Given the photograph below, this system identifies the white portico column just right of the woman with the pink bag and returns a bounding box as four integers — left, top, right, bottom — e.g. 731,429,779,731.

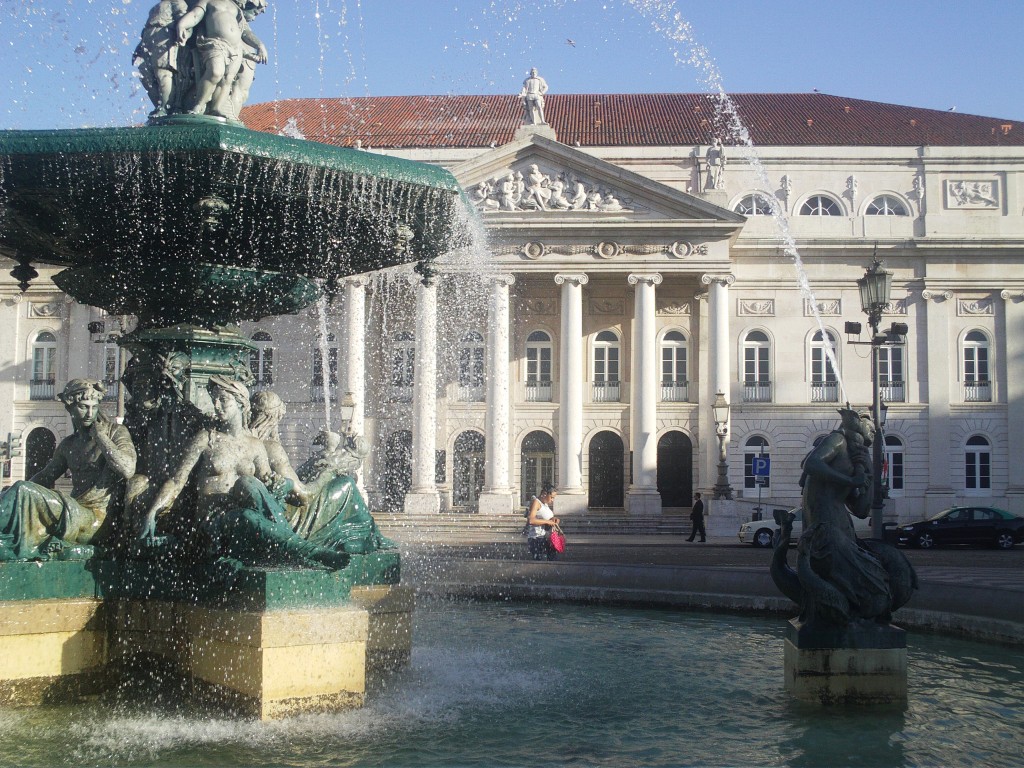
555,274,590,512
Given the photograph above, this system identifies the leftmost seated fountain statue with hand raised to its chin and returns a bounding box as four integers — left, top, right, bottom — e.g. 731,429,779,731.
0,379,135,560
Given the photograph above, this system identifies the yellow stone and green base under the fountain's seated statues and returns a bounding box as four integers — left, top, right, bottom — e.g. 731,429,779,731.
0,563,413,720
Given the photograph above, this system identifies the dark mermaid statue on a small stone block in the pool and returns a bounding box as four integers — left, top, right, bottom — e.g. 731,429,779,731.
771,409,918,627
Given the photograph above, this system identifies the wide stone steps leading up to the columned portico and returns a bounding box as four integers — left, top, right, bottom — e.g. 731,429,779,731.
374,509,690,543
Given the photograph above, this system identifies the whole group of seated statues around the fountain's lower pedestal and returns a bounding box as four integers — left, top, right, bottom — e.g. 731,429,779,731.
0,375,394,569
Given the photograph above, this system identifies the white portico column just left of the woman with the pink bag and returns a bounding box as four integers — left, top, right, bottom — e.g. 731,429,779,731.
478,274,515,514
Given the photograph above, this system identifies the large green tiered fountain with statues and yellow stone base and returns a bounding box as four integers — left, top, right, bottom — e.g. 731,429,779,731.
0,0,461,718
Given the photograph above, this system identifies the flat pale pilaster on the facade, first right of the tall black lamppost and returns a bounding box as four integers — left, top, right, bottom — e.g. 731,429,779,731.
921,289,964,515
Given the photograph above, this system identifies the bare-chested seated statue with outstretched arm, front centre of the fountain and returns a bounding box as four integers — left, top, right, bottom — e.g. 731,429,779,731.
139,375,349,569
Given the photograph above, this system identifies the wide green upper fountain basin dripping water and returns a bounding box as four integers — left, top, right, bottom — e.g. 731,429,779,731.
0,117,462,326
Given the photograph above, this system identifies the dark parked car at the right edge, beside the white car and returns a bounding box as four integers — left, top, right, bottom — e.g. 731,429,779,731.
896,507,1024,549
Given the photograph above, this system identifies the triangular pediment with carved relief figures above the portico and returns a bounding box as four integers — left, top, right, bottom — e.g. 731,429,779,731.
451,134,745,227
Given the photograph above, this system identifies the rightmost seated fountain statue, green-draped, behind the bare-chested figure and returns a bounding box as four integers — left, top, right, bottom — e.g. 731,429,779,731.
252,391,395,554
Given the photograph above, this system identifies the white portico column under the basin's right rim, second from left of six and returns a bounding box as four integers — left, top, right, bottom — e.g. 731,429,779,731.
406,281,440,514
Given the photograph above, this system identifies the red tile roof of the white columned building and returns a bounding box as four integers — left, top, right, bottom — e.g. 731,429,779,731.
242,93,1024,148
